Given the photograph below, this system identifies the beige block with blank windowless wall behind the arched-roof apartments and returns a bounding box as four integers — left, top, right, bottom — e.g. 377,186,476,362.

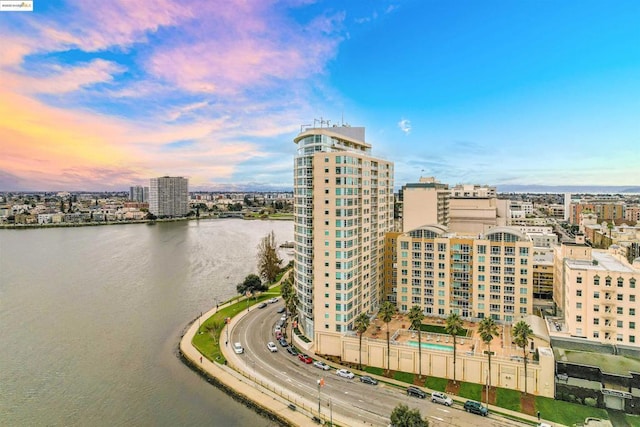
400,177,449,230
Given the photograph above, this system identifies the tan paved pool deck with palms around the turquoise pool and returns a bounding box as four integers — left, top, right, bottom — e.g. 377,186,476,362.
363,314,548,358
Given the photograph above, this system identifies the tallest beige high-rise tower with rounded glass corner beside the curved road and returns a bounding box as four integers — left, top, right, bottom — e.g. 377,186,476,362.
294,125,394,348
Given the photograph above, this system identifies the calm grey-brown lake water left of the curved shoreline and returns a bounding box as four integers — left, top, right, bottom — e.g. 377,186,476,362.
0,219,293,427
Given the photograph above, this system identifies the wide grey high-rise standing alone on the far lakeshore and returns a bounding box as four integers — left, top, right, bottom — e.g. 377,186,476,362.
149,176,189,218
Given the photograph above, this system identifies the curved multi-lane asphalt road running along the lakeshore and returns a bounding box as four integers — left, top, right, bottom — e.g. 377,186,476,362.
230,300,528,427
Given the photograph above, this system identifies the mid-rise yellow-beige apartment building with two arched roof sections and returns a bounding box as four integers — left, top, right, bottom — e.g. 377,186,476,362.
394,225,533,323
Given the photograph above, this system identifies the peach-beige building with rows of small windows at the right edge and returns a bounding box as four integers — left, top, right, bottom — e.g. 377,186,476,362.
554,238,640,347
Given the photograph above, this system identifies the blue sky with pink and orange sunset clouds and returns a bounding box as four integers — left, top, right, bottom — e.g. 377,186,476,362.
0,0,640,191
